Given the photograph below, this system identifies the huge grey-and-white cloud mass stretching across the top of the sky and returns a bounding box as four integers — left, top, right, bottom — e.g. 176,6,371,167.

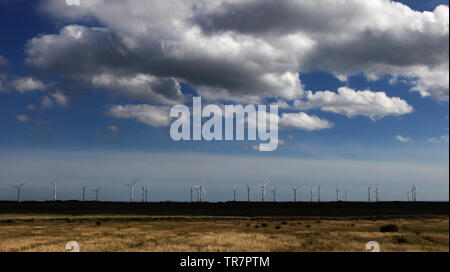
27,0,449,103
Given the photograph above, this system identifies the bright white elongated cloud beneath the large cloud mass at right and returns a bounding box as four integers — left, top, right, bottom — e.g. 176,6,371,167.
294,87,413,120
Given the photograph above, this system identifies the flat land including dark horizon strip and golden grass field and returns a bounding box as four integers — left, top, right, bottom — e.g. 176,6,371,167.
0,202,449,252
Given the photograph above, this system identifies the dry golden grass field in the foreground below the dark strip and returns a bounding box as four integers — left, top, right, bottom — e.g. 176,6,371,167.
0,214,449,252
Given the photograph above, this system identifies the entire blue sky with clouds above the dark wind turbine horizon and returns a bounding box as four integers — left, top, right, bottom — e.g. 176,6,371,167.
0,0,449,201
